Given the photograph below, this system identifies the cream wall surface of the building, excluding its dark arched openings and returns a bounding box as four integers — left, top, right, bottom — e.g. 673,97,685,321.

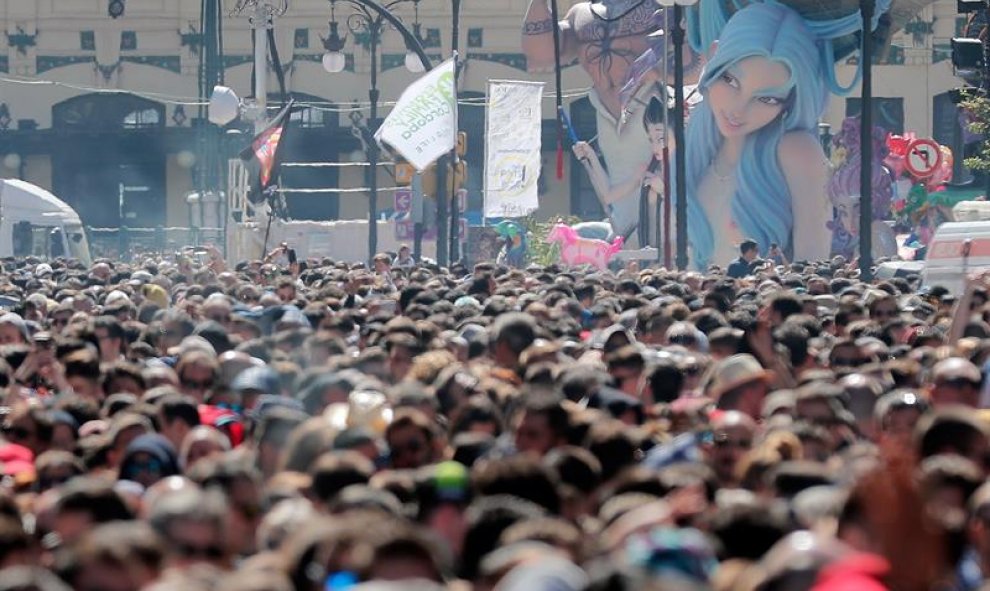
0,0,976,231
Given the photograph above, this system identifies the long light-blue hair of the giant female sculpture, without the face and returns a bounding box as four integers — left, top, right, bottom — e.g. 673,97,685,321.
685,0,890,268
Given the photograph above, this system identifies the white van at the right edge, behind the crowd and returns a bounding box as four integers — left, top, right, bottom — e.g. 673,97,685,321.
921,221,990,295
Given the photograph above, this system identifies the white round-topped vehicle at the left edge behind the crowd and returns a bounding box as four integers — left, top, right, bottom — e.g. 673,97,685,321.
0,179,91,265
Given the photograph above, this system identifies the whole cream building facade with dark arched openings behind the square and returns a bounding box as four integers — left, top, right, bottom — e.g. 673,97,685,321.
0,0,980,236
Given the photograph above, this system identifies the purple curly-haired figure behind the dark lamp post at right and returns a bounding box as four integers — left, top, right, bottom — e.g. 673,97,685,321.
828,117,897,259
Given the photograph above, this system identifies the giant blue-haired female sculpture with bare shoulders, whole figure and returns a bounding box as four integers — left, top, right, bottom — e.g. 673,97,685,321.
685,0,889,268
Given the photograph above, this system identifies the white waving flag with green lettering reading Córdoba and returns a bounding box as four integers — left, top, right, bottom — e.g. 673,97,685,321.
375,59,457,171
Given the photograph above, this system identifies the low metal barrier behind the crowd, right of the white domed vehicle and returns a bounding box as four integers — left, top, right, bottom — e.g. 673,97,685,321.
86,226,224,262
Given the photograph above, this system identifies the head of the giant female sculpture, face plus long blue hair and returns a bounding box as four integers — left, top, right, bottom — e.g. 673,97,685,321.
686,3,828,268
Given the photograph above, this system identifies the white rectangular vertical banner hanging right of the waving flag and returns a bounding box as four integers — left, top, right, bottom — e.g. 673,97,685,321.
485,80,543,218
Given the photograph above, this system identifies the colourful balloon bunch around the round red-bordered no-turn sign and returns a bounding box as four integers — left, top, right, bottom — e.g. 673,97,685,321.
885,132,960,250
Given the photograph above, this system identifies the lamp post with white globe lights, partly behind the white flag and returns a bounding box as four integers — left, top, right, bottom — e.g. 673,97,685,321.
323,0,431,260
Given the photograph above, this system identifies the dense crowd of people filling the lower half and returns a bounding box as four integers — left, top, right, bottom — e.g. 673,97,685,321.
0,249,990,591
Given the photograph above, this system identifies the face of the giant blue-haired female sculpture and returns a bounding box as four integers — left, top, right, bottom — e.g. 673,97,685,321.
708,56,791,138
